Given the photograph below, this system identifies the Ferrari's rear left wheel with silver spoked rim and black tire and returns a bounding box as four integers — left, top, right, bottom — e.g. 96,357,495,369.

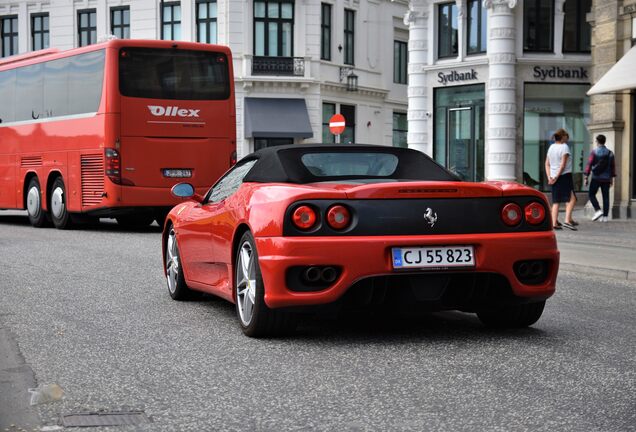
234,231,298,338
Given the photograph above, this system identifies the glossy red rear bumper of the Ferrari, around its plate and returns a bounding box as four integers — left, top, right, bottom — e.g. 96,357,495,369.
256,231,559,308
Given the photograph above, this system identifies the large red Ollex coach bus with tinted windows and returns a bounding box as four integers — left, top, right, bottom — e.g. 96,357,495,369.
0,40,236,228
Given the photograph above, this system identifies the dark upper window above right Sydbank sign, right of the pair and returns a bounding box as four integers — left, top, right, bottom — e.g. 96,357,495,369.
563,0,592,53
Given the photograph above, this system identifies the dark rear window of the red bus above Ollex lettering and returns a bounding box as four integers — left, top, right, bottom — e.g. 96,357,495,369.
119,48,230,100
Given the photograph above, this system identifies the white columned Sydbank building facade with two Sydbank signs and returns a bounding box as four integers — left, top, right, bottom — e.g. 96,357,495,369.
405,0,592,192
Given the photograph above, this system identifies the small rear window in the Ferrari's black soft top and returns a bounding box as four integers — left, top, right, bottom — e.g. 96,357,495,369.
300,152,398,177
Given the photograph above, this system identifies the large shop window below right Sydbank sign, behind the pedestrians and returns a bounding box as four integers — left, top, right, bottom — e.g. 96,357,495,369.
523,83,592,192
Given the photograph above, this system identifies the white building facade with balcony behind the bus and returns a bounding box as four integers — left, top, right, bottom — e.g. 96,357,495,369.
0,0,408,157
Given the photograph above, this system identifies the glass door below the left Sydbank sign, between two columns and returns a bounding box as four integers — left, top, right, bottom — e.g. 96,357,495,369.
446,107,477,181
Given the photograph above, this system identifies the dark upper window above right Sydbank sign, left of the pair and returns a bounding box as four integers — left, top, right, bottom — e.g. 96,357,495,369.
523,0,554,52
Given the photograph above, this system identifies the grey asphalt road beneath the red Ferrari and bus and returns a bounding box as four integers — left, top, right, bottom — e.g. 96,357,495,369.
0,212,636,431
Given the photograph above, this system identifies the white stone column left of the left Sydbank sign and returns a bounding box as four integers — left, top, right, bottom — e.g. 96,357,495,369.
404,0,433,156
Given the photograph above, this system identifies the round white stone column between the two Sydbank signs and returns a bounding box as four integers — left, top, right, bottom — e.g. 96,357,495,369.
484,0,517,180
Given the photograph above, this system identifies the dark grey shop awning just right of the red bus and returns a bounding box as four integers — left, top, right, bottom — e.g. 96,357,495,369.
244,98,314,138
